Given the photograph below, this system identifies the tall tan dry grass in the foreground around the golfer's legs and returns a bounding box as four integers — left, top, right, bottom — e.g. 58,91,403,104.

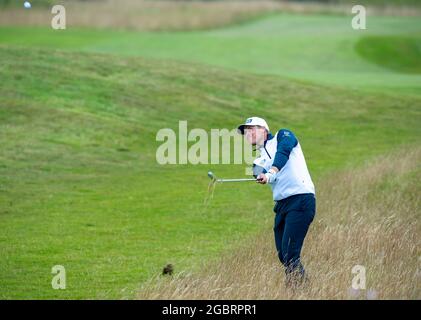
138,148,421,299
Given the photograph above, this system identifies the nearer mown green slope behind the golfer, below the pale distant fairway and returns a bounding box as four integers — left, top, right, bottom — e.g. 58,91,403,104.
0,47,421,298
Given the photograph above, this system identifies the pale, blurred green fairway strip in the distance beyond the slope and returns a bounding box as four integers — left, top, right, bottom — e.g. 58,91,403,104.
0,14,421,95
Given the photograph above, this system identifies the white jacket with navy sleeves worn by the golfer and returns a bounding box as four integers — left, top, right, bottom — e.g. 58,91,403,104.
253,129,315,201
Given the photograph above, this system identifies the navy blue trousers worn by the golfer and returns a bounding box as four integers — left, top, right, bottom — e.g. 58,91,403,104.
273,193,316,283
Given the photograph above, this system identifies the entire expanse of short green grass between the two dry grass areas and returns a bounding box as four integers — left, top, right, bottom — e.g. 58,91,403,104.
0,11,421,299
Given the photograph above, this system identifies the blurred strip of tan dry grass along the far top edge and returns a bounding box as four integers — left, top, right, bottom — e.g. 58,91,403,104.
0,0,421,31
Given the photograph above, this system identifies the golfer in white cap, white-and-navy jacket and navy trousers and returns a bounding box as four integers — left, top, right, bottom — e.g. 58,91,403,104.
238,117,316,287
